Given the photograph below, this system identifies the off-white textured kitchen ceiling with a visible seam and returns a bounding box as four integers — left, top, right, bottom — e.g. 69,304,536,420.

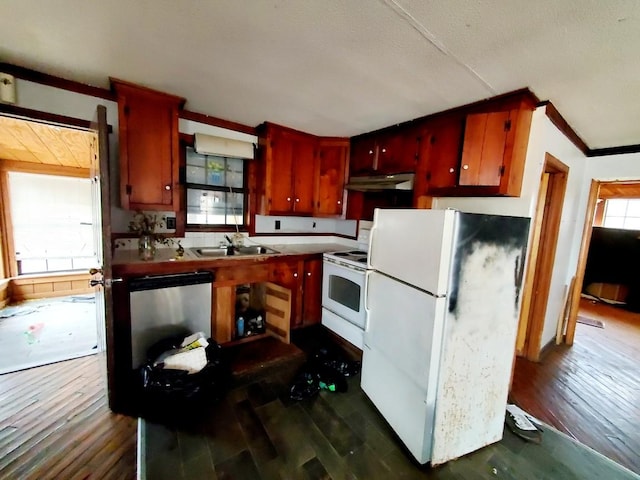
0,0,640,149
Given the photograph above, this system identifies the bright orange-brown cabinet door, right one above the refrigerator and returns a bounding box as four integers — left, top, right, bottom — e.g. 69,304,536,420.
459,111,511,187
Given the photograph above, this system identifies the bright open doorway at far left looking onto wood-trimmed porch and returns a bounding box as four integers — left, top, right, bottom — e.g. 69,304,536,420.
0,116,99,373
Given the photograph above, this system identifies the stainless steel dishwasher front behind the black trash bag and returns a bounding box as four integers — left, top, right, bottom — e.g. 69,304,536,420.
129,272,213,368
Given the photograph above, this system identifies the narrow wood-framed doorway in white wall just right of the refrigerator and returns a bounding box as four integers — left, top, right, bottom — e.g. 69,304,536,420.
516,153,569,361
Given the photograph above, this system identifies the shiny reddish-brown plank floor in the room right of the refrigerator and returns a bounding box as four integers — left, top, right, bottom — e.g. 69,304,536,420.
511,298,640,474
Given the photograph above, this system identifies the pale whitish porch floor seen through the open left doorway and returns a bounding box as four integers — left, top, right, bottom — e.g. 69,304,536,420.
0,295,98,374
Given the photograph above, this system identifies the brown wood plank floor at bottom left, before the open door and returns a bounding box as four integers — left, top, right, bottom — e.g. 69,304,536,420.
0,355,137,480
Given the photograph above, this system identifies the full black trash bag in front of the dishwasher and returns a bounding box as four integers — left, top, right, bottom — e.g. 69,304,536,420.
139,337,231,420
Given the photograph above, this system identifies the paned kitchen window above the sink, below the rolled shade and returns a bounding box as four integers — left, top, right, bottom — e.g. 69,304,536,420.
186,147,246,229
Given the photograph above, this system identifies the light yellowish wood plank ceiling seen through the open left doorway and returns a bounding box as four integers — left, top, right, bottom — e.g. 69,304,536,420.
0,116,94,169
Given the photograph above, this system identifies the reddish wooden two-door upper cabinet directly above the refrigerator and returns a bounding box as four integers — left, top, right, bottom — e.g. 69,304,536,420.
414,93,535,198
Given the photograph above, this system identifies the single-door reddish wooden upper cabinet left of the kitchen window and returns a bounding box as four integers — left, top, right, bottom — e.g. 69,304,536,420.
111,79,185,211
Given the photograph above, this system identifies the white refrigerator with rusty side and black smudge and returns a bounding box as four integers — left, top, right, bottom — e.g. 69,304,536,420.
361,209,529,465
